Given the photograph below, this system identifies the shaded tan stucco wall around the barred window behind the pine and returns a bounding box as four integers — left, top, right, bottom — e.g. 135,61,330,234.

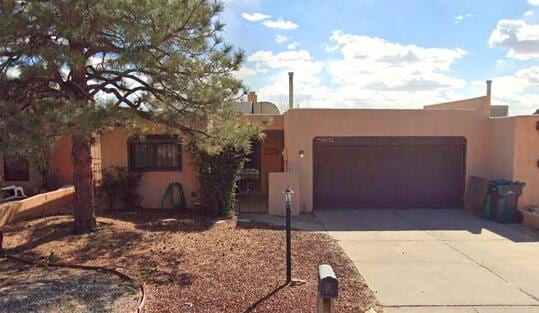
101,129,197,208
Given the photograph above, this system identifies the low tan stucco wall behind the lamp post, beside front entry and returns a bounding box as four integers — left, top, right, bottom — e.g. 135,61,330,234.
268,172,301,216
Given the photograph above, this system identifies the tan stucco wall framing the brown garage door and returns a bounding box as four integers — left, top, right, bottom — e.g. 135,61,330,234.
284,103,496,211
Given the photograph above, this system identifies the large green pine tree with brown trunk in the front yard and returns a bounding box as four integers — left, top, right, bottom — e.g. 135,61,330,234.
0,0,243,233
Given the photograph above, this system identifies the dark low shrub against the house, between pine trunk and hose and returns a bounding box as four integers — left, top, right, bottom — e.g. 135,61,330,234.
102,166,143,211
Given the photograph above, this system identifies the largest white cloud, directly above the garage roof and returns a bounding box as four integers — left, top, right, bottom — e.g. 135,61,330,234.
316,31,466,108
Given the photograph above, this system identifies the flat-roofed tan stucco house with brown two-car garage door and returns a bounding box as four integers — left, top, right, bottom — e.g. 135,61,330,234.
0,83,539,214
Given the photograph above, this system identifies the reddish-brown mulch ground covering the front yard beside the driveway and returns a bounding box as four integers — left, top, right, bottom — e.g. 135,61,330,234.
4,212,381,313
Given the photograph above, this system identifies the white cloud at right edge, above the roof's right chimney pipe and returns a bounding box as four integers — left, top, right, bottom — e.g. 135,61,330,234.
489,17,539,60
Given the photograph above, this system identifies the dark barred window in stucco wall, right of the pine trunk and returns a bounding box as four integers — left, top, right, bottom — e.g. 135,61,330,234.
129,135,182,171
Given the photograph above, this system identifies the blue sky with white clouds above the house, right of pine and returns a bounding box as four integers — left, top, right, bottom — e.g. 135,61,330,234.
220,0,539,115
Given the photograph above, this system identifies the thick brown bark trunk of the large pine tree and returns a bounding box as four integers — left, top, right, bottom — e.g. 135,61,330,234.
71,135,96,234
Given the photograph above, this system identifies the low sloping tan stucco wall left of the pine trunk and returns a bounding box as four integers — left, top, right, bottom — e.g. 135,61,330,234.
0,187,75,227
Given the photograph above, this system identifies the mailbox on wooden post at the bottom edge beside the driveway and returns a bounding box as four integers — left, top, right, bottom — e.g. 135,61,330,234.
318,264,339,313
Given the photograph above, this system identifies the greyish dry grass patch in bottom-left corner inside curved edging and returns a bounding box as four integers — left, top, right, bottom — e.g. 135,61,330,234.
0,258,139,313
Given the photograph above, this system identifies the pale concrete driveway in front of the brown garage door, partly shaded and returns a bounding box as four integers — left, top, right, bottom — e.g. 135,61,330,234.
316,209,539,313
